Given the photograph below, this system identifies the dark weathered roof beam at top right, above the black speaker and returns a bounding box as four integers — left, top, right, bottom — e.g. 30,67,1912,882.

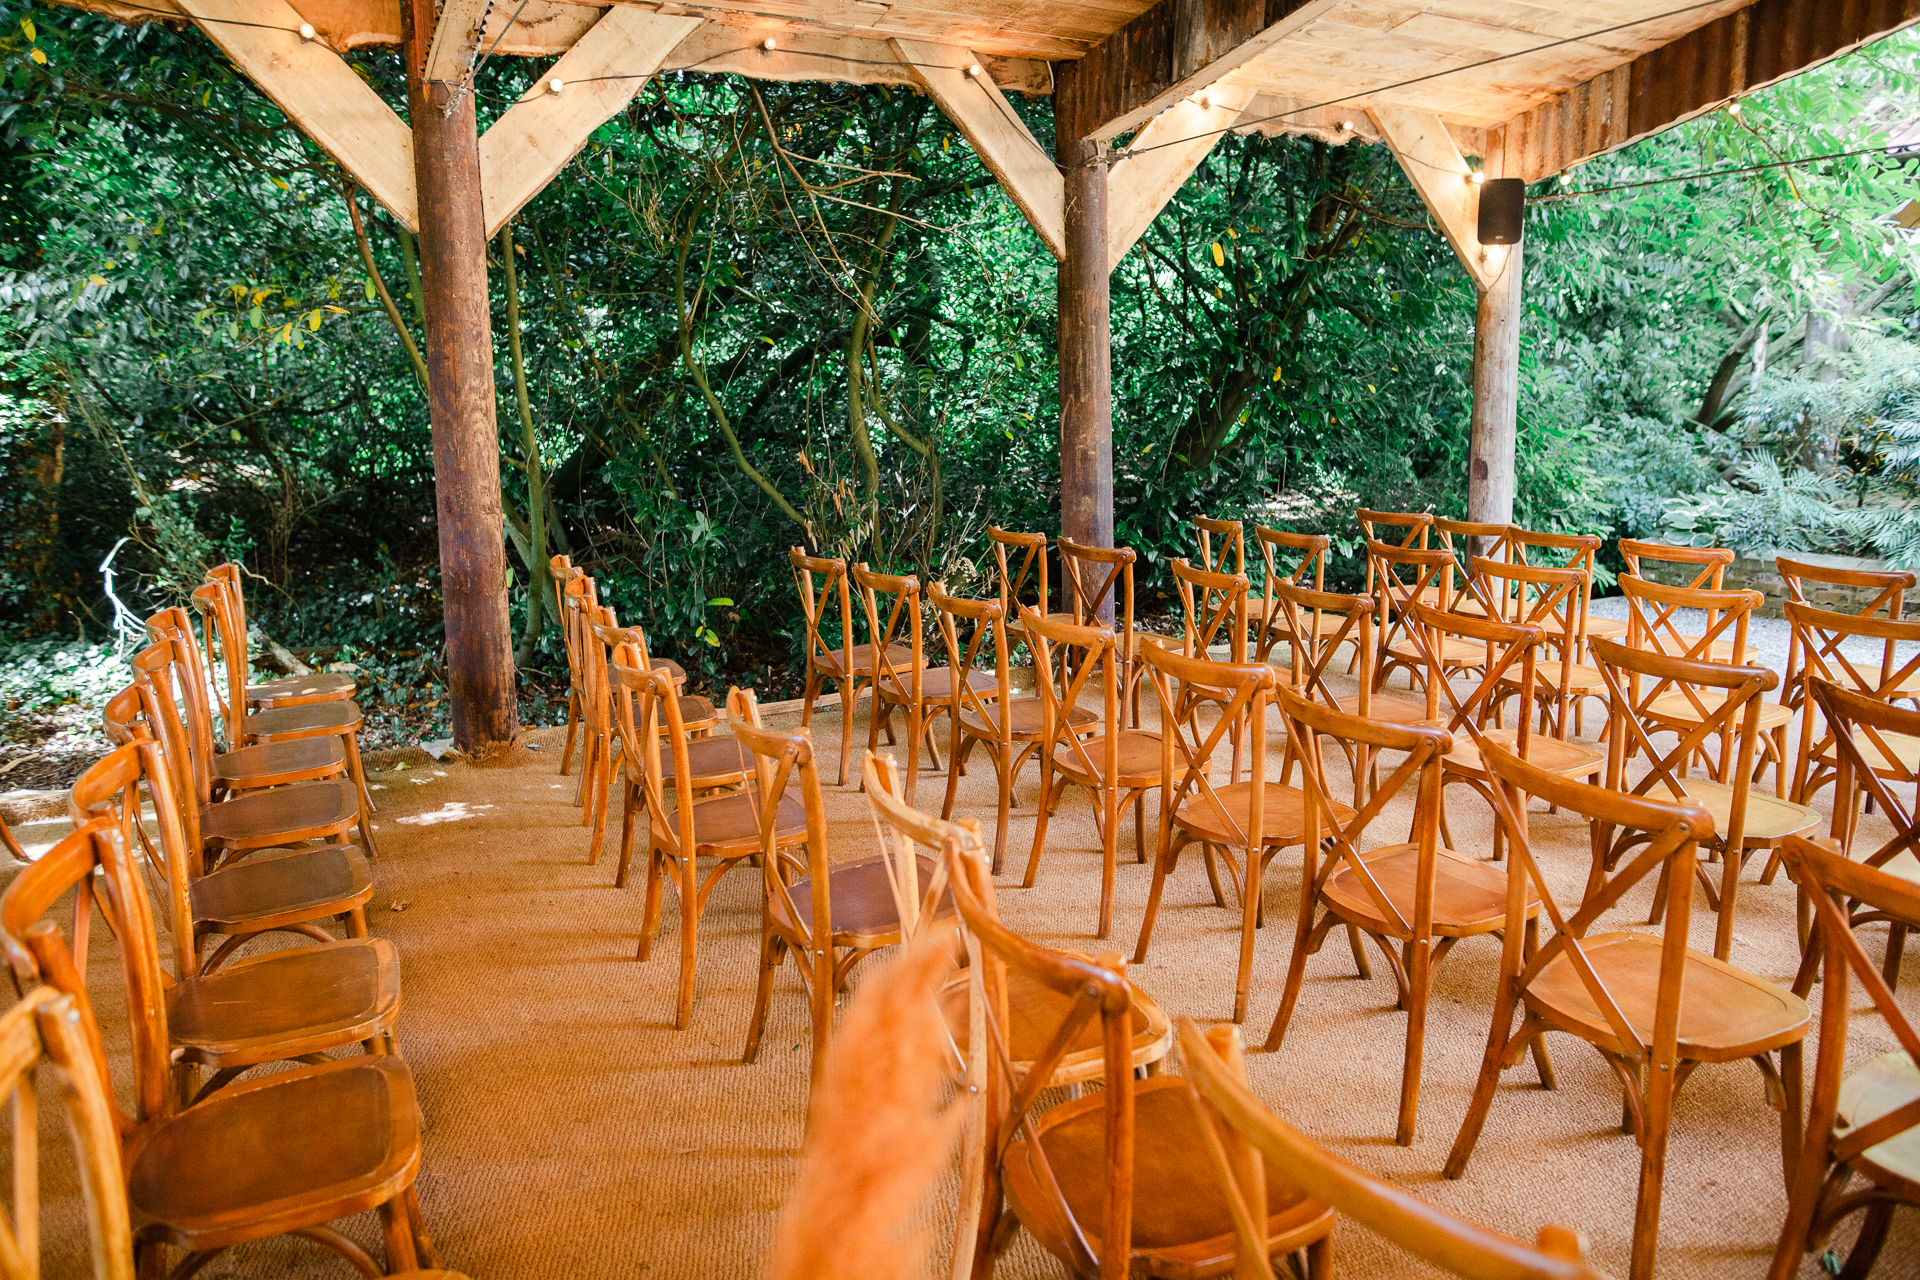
1501,0,1920,182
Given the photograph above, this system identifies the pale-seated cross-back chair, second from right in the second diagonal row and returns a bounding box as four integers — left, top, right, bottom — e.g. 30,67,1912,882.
1590,639,1820,960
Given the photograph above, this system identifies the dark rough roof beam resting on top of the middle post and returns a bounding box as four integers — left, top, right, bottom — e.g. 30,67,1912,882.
1054,0,1342,142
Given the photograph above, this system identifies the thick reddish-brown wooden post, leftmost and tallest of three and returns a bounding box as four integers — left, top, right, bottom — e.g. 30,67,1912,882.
399,0,518,756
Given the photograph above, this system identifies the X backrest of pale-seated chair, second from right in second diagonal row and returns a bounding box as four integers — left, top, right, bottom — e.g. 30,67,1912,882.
1594,635,1780,835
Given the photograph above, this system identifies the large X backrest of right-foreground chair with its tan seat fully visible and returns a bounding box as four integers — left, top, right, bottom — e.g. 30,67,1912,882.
1480,741,1713,1071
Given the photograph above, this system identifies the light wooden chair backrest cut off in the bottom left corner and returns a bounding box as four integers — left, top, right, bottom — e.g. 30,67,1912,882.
0,986,134,1280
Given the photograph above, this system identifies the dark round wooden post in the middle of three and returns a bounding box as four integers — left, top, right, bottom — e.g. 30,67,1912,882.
1054,63,1114,560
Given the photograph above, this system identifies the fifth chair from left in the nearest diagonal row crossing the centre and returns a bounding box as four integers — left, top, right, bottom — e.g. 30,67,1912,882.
1133,645,1328,1021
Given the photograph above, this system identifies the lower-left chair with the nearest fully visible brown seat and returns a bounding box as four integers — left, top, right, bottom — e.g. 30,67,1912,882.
0,825,440,1276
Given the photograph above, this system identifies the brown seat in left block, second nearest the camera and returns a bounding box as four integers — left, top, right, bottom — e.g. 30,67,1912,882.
167,938,399,1067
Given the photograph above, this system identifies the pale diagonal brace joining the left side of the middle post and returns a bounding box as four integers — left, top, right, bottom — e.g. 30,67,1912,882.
887,40,1066,257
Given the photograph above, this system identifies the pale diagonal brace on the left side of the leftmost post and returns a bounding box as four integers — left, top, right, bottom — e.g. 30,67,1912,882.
179,0,420,230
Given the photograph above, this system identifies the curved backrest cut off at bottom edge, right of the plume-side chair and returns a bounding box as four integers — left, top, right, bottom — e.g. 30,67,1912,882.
1179,1017,1603,1280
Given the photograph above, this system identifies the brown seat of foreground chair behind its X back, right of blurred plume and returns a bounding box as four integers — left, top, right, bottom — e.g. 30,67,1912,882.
1002,1077,1332,1276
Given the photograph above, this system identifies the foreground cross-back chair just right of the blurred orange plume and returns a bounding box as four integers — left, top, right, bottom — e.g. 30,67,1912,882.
947,825,1332,1280
